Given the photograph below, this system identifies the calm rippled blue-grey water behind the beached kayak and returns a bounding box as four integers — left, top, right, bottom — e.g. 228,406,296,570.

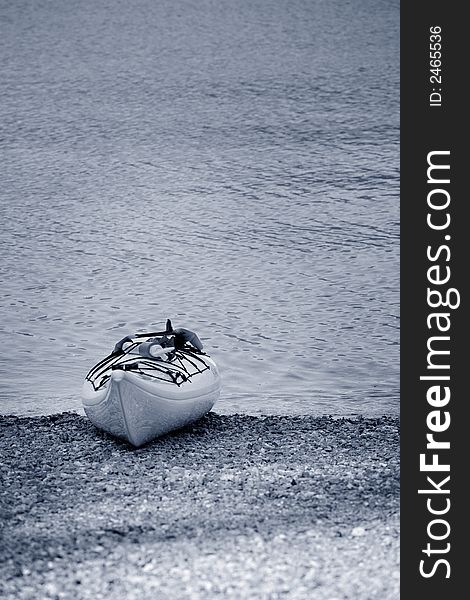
0,0,399,415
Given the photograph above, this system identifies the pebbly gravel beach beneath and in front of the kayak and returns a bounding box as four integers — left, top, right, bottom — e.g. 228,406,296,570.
0,413,399,600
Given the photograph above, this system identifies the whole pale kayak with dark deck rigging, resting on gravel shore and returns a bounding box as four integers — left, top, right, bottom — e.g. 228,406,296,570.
82,321,221,446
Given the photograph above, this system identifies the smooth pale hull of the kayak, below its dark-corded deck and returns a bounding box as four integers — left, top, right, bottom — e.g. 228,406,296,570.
82,358,220,447
